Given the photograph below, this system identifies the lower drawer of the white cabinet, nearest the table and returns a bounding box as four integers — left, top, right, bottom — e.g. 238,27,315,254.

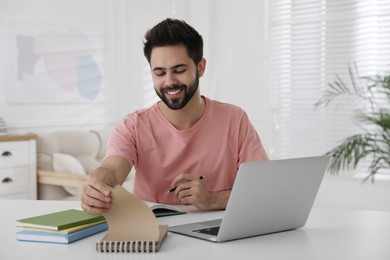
0,167,30,195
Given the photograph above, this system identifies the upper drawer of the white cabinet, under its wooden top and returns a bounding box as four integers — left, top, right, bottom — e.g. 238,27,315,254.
0,141,30,167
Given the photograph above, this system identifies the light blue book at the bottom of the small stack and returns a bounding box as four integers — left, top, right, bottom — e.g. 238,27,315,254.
16,222,108,244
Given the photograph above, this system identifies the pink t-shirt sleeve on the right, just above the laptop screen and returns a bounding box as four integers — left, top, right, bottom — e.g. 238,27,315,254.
238,112,269,165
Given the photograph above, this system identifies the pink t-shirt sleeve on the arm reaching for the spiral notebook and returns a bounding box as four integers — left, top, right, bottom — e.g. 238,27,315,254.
104,115,137,168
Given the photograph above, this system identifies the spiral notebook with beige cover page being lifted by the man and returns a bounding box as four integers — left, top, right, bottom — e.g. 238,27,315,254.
96,186,168,252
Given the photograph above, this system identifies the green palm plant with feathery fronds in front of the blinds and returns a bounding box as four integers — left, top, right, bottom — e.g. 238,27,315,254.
315,64,390,181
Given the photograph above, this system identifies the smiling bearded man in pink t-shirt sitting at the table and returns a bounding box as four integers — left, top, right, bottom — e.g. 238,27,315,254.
81,19,268,214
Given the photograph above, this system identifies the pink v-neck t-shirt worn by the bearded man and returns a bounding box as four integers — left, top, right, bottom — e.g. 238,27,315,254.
106,98,268,204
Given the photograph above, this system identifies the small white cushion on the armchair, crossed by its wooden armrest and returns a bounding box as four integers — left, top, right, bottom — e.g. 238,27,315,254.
53,153,87,195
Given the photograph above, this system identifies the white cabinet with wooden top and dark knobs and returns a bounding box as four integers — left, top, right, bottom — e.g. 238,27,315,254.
0,135,37,199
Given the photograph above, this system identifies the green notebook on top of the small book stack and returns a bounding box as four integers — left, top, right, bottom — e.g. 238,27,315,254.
16,209,105,230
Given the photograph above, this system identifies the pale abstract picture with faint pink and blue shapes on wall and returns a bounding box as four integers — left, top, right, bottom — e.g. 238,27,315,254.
6,21,105,104
